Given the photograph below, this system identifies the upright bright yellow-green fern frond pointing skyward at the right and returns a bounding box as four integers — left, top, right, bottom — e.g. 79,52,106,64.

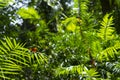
98,14,115,41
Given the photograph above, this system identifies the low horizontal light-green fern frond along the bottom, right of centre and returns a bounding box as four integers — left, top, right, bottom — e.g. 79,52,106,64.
55,65,98,78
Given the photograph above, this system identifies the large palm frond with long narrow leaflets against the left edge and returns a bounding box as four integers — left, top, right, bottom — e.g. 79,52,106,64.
0,37,29,78
